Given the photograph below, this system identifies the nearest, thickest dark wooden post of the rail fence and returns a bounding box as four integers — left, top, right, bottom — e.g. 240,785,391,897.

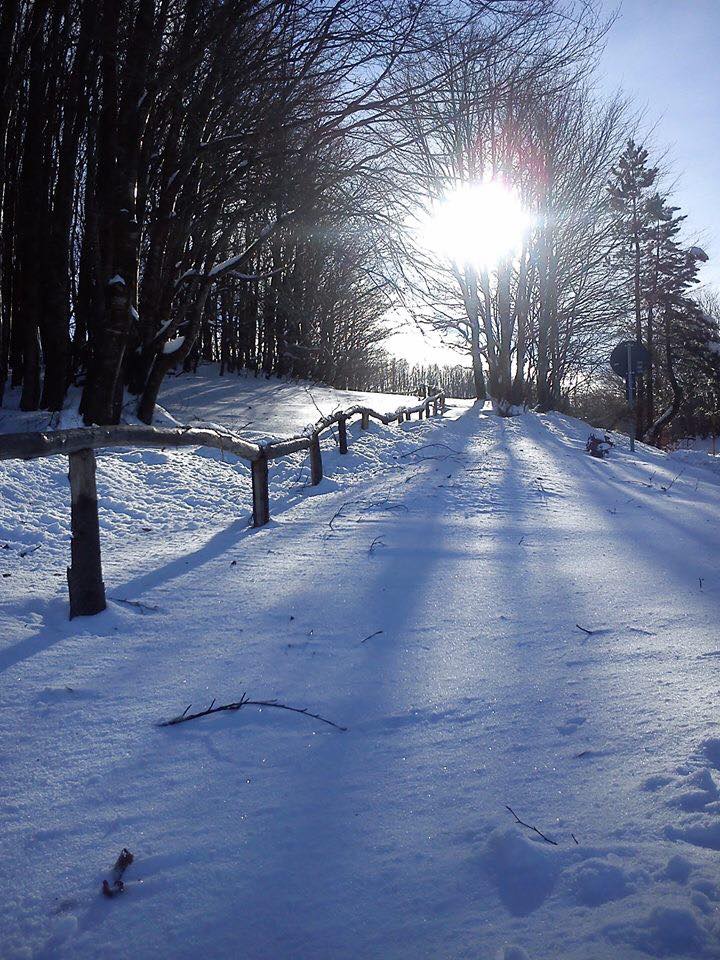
67,450,107,620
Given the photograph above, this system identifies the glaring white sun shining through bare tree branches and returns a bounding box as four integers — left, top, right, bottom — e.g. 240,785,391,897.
424,180,531,269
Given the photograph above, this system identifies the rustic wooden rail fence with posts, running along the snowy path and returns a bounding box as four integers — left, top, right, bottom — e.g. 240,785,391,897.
0,391,445,618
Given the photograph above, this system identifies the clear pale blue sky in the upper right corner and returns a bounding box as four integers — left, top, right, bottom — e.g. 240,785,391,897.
600,0,720,288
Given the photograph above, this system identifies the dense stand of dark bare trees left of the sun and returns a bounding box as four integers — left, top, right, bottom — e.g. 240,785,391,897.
0,0,450,423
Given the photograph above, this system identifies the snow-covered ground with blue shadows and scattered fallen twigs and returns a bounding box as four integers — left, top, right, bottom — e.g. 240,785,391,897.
0,378,720,960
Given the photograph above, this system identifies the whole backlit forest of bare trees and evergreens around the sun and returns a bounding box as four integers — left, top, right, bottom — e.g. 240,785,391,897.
0,0,720,445
